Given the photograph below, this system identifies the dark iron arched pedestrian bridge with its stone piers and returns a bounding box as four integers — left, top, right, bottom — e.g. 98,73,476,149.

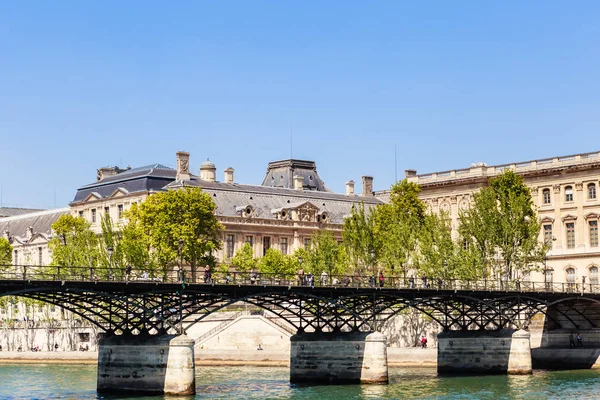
0,266,600,393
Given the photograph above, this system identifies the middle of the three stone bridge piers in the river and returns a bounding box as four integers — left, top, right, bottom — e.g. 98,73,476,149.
290,332,388,384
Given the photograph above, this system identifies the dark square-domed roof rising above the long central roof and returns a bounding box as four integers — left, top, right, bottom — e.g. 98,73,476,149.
262,159,329,192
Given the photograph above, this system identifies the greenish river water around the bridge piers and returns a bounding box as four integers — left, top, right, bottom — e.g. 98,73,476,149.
0,364,600,400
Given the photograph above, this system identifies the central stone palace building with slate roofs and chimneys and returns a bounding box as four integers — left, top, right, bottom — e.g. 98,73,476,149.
70,152,381,262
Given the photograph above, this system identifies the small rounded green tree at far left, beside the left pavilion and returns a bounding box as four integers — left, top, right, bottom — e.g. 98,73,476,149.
48,214,99,277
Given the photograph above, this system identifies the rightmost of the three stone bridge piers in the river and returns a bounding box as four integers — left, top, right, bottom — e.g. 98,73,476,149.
438,329,532,375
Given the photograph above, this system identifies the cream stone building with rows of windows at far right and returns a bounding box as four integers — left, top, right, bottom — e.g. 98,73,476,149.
375,152,600,284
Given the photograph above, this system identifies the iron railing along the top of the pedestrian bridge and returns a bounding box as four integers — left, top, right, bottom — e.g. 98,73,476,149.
0,265,600,294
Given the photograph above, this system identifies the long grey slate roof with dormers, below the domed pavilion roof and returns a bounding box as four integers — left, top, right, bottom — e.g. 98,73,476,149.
168,177,383,224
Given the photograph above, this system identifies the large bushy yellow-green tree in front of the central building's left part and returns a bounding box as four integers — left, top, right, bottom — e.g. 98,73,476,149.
124,187,223,280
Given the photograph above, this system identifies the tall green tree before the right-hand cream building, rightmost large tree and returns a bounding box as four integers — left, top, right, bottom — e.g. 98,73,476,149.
459,171,545,279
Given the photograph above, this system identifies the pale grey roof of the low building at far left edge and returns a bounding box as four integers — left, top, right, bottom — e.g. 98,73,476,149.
0,208,69,242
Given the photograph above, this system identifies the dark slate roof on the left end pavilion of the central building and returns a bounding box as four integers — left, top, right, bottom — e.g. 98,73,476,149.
71,164,177,204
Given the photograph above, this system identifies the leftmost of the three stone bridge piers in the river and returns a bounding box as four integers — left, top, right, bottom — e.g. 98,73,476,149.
98,335,196,395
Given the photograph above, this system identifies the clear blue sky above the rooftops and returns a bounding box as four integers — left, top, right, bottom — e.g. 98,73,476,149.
0,0,600,207
